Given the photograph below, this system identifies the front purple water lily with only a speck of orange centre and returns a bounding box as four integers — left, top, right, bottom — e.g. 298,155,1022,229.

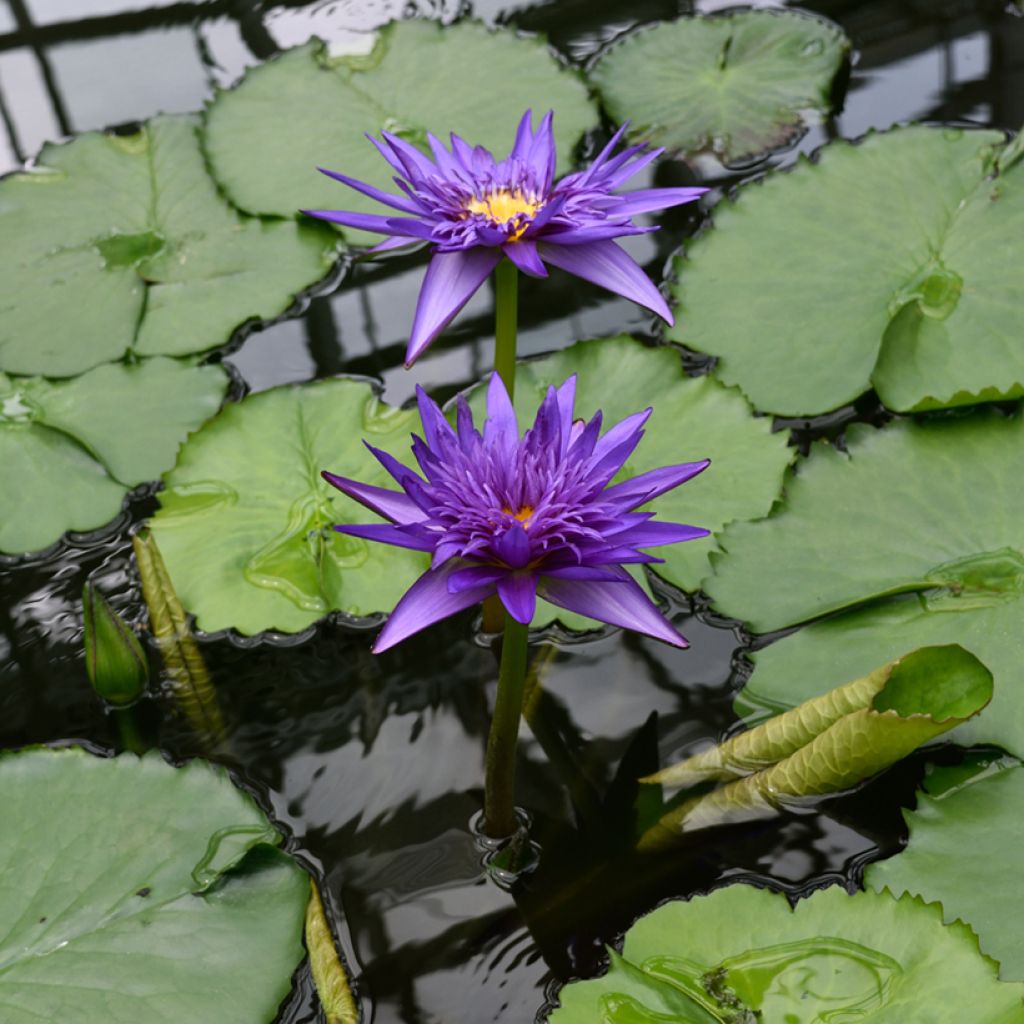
323,374,709,652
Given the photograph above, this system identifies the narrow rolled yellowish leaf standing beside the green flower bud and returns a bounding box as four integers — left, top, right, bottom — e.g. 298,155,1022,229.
131,529,224,745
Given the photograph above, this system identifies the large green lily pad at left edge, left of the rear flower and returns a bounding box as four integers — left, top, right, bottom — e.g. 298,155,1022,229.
0,117,336,377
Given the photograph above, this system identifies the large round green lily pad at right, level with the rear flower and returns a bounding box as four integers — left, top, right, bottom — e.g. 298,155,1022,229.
669,126,1024,416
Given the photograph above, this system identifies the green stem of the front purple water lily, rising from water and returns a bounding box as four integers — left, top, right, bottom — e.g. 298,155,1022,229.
483,614,529,839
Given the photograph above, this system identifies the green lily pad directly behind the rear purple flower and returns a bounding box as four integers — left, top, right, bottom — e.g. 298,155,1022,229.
206,20,598,245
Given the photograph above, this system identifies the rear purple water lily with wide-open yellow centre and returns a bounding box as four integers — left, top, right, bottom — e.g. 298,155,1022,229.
303,111,708,366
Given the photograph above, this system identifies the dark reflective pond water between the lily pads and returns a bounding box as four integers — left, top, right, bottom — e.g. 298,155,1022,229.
0,0,1024,1024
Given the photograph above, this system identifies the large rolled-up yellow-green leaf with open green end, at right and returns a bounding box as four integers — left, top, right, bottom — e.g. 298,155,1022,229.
640,644,992,849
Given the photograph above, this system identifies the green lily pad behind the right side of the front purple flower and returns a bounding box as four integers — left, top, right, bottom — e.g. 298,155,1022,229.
462,336,796,629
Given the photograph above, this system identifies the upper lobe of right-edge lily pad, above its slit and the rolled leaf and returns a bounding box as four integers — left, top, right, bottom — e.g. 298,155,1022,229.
706,412,1024,634
